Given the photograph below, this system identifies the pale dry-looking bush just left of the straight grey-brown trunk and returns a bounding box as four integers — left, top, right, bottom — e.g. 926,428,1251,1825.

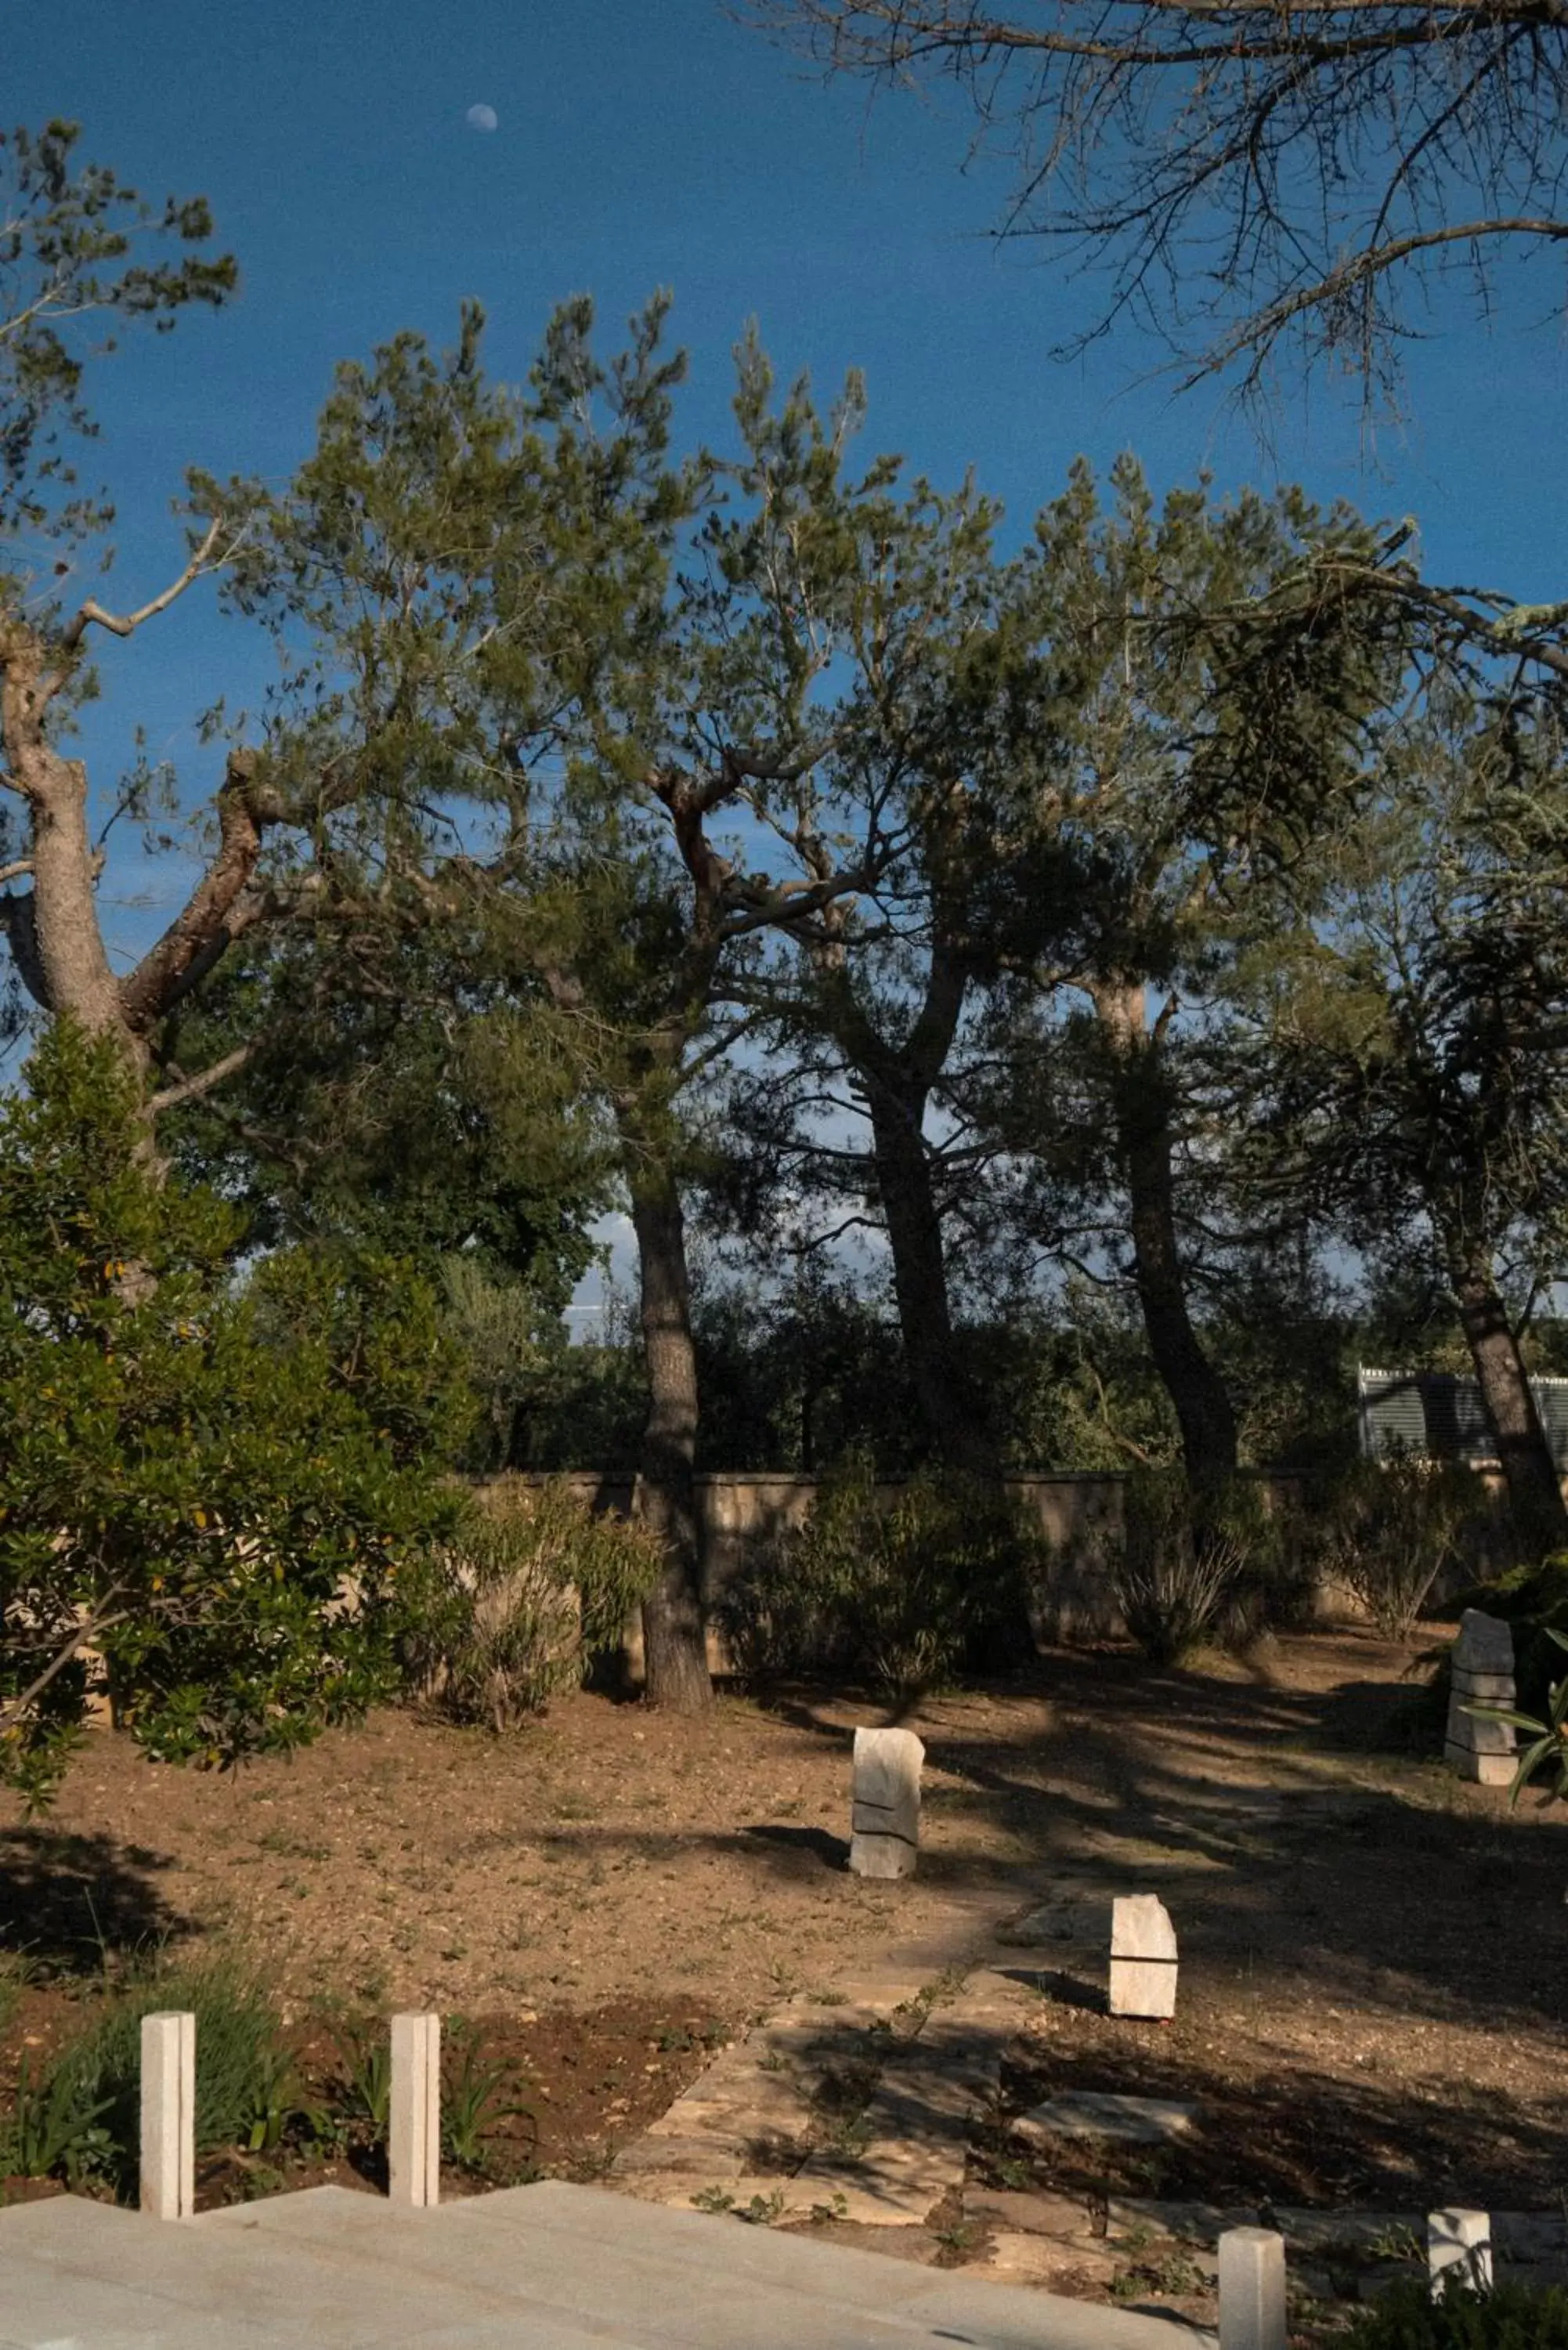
399,1478,663,1730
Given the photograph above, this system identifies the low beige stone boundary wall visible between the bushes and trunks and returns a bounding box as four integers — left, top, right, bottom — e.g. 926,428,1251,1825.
496,1469,1316,1676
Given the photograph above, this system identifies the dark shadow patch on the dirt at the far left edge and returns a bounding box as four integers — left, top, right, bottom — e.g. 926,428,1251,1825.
0,1828,195,1974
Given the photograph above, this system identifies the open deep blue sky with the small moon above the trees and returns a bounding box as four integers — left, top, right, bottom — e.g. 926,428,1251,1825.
12,0,1568,1307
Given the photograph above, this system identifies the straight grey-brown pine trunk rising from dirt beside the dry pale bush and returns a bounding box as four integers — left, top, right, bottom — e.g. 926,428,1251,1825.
627,1137,712,1713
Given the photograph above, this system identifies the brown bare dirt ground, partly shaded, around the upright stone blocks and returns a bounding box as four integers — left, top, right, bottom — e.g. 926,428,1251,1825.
0,1633,1568,2209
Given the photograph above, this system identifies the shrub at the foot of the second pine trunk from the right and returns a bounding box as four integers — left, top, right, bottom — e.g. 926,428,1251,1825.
1110,1469,1279,1666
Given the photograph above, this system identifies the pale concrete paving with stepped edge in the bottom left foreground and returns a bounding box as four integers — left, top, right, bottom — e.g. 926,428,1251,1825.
0,2181,1201,2350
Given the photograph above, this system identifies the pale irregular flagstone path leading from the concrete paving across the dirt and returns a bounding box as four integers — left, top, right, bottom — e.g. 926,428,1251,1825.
604,1866,1568,2317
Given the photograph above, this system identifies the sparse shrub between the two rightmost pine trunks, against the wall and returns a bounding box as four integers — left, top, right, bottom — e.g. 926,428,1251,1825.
1314,1452,1488,1638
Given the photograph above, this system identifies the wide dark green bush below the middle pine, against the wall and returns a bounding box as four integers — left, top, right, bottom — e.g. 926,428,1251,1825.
714,1455,1044,1701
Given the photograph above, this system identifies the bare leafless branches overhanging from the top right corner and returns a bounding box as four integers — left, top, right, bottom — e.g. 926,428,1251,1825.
731,0,1568,392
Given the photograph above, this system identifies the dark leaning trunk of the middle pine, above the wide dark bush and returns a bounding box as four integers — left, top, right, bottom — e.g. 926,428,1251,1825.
863,1062,999,1478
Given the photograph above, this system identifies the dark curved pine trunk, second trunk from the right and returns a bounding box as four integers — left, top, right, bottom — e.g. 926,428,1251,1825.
1093,980,1237,1495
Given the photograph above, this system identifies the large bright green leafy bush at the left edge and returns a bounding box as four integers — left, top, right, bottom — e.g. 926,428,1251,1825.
0,1022,472,1802
